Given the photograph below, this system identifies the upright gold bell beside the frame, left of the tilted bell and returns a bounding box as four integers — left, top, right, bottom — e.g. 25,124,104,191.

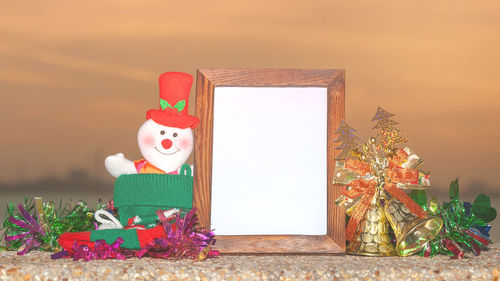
347,204,395,256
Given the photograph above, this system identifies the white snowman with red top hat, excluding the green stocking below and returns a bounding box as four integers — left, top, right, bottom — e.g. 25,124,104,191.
104,72,199,177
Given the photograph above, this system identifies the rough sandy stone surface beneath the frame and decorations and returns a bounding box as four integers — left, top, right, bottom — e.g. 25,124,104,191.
0,247,500,280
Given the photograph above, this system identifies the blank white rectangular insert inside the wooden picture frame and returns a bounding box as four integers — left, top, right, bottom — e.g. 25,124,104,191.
211,87,328,235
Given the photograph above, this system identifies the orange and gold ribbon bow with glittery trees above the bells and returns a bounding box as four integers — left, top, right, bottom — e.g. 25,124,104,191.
333,107,430,242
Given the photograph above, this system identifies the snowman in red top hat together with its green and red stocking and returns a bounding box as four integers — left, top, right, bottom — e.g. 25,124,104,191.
58,72,199,251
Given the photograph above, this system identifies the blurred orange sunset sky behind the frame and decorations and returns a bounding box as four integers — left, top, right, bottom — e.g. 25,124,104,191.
0,0,500,196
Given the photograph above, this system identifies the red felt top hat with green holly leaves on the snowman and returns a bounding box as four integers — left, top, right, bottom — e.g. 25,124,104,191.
146,72,200,129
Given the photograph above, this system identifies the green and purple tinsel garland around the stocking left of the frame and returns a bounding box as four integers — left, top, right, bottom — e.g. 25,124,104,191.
0,198,219,261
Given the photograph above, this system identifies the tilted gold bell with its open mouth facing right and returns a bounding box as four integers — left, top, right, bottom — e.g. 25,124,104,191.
384,198,443,256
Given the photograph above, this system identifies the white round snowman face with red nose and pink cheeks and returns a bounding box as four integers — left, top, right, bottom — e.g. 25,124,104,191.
137,119,193,173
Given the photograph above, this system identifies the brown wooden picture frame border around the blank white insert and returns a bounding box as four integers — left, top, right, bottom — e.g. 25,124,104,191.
193,69,346,254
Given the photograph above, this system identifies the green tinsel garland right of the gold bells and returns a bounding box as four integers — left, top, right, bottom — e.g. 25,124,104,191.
411,179,497,258
